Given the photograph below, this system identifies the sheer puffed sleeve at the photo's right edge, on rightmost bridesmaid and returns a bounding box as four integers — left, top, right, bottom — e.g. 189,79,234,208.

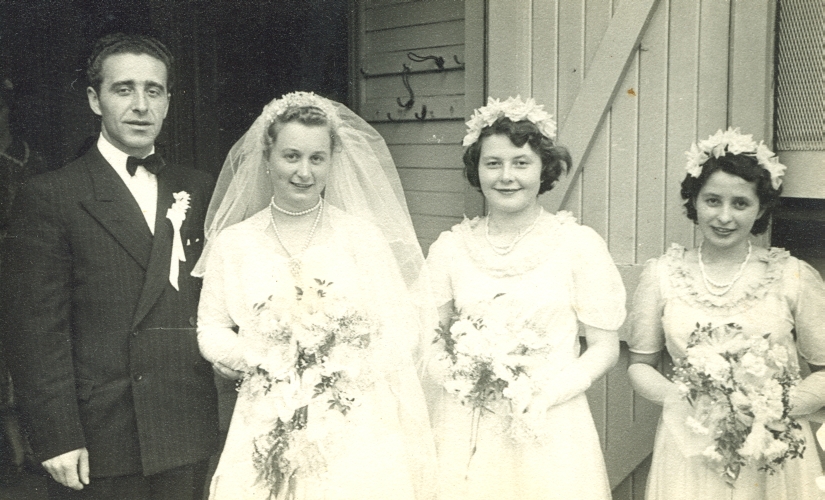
786,259,825,366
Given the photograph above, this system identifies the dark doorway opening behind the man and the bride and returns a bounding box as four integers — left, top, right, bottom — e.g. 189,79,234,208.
0,0,349,175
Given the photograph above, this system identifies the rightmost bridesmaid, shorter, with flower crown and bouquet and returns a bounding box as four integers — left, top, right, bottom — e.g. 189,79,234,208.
628,129,825,500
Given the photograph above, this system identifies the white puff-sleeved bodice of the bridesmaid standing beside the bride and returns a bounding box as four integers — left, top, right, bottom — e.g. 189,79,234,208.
427,212,625,359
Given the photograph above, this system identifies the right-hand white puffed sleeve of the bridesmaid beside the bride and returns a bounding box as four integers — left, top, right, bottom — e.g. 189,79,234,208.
572,226,626,330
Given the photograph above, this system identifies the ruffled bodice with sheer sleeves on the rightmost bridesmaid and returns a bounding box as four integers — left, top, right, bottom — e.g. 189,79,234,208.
629,244,825,364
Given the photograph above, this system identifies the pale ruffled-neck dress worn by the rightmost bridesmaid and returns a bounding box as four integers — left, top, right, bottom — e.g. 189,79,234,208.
628,244,825,500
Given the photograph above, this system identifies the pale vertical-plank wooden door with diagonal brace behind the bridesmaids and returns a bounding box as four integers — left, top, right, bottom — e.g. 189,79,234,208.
486,0,774,498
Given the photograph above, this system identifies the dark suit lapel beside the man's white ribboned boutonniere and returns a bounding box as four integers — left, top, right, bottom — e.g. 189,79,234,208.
132,170,179,328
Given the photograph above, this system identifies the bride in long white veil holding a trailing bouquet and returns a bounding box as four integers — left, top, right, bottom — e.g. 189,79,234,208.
195,92,435,500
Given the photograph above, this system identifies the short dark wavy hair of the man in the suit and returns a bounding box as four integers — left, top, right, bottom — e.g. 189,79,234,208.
86,33,174,92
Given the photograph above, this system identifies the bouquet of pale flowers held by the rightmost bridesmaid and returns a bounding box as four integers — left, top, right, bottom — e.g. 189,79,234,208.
673,323,805,486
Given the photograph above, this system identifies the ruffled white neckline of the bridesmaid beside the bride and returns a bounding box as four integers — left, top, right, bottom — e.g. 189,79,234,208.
452,210,578,278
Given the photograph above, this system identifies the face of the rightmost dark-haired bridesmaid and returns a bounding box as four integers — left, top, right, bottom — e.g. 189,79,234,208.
695,170,764,248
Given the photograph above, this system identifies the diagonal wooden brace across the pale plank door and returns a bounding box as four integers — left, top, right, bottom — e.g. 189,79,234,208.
540,0,659,212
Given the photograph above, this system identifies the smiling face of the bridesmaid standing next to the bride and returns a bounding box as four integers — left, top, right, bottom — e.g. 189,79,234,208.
478,134,541,213
